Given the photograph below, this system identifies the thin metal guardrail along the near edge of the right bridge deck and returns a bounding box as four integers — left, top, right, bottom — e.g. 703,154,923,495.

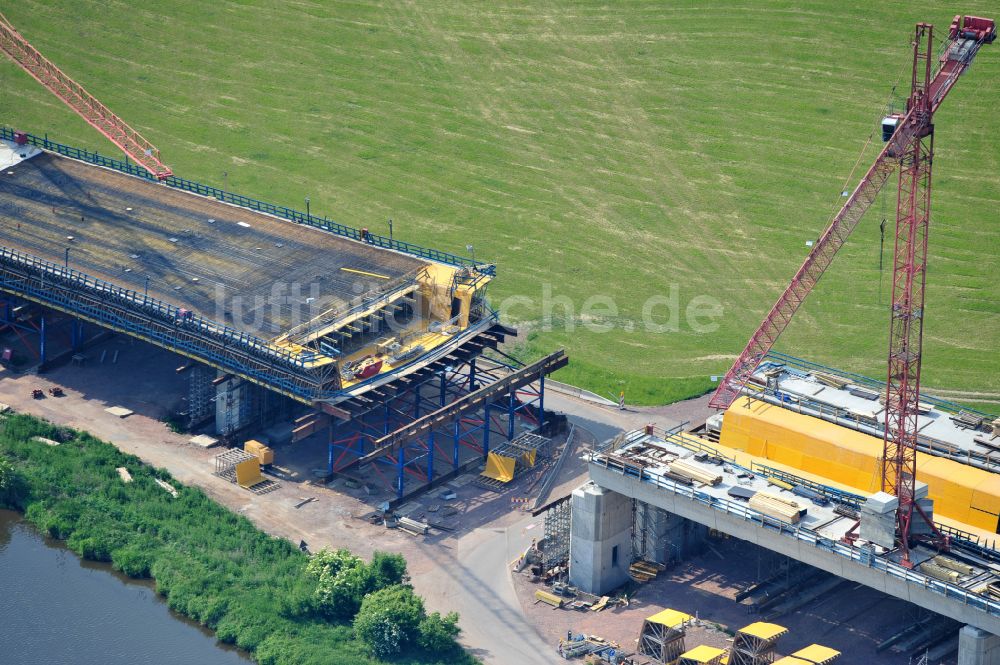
590,454,1000,617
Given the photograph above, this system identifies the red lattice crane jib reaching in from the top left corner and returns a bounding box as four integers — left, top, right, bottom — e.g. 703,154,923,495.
0,14,173,180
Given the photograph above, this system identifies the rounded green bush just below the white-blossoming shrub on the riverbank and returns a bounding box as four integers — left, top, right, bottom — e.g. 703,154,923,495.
354,584,425,658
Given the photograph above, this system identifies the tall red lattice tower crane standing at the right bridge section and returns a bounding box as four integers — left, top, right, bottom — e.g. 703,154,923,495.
709,16,996,564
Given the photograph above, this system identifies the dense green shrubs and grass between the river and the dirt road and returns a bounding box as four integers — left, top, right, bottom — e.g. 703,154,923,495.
0,415,475,665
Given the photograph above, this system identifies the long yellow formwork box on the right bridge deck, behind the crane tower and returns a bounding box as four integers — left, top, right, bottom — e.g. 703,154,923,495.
719,398,1000,533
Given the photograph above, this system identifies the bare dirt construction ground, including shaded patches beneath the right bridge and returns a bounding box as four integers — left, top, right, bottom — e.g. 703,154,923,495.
0,336,956,665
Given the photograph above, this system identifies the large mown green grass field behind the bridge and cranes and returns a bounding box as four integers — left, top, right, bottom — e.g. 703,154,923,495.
0,0,1000,410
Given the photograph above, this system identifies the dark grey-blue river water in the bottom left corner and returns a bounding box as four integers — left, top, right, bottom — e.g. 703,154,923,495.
0,510,252,665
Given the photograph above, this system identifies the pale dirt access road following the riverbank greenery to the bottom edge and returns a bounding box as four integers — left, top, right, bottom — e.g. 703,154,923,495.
0,338,696,665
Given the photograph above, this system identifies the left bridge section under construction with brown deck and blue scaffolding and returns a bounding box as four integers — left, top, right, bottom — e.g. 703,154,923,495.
0,128,566,497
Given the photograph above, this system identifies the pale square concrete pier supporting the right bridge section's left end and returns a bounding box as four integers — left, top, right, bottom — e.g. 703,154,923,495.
569,483,632,594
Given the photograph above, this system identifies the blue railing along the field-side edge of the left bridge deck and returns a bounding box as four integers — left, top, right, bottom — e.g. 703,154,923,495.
0,127,496,276
